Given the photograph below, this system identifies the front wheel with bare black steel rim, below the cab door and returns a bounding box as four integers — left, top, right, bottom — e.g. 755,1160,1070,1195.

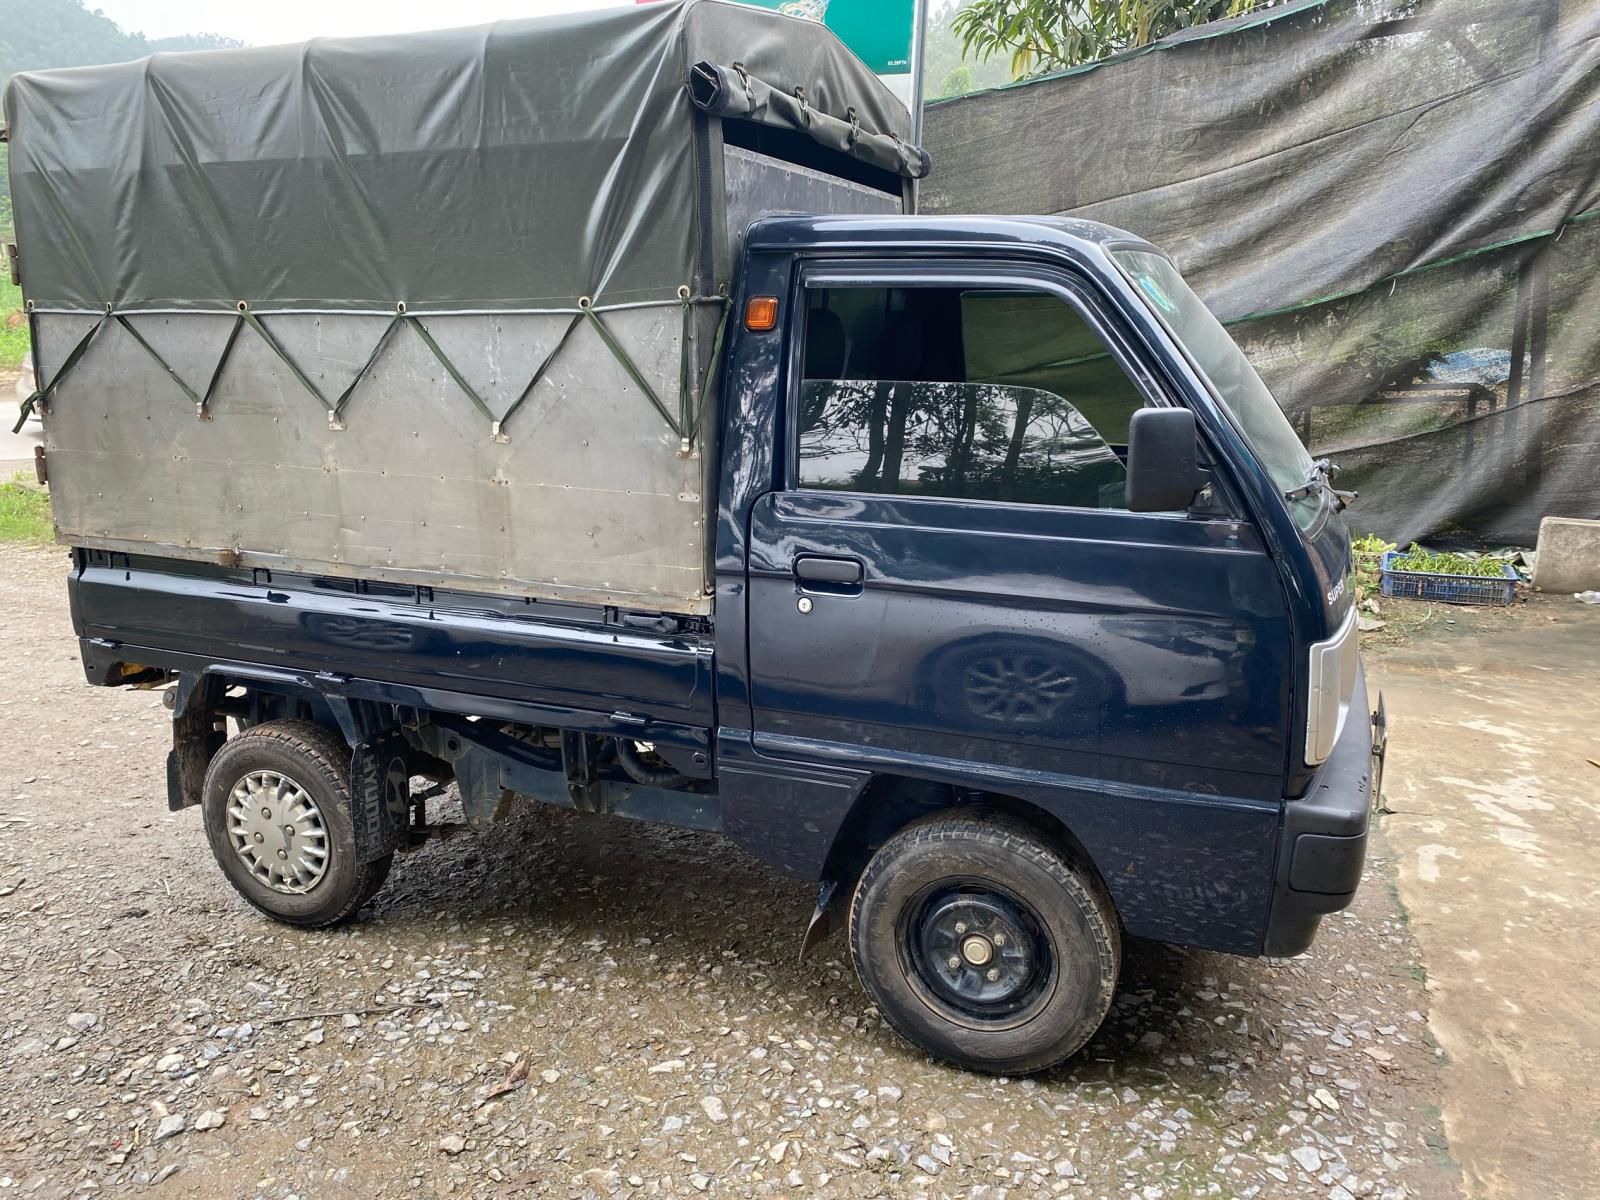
850,813,1122,1075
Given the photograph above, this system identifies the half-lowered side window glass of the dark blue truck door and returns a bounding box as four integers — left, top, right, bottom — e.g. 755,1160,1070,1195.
798,288,1144,509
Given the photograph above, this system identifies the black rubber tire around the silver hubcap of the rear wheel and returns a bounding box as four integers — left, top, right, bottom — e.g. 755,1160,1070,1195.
200,720,394,930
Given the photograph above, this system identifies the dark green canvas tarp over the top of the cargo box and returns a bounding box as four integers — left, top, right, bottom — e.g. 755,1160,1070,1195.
5,0,909,310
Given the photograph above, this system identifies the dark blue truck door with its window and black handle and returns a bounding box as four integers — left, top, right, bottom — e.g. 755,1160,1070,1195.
749,266,1291,809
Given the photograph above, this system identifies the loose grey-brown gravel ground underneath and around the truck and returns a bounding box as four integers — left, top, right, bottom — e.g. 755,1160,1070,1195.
0,546,1456,1200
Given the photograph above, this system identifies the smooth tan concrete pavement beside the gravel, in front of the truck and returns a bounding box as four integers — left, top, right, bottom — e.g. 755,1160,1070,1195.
1368,597,1600,1200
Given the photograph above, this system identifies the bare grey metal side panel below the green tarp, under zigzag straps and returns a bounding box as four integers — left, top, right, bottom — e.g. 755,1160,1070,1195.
38,307,706,613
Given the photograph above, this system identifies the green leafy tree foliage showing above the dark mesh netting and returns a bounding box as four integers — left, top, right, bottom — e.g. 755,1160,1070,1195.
952,0,1278,78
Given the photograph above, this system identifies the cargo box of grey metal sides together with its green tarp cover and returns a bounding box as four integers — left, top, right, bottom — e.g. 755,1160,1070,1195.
5,0,926,611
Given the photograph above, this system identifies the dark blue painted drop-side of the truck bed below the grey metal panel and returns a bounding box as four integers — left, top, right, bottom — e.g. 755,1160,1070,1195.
69,550,714,747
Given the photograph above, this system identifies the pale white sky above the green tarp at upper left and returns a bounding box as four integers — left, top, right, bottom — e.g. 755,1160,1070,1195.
90,0,632,46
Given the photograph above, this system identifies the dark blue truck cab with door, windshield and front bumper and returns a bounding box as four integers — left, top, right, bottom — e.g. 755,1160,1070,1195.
717,218,1381,955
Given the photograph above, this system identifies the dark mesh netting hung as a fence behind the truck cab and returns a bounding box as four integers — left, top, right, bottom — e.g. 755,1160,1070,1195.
922,0,1600,544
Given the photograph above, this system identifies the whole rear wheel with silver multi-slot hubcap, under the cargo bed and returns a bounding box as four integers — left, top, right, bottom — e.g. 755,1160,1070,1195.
202,720,392,928
